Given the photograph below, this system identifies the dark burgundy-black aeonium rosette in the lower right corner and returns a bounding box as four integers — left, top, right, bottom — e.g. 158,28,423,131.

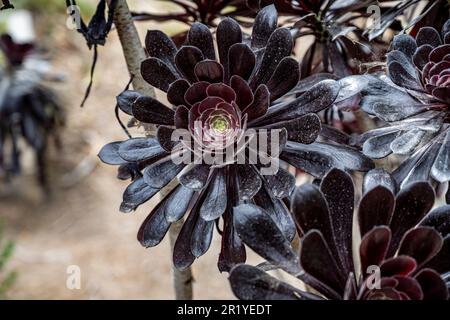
230,169,450,300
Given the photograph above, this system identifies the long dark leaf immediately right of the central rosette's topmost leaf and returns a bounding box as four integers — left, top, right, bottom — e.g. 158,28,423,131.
250,28,293,89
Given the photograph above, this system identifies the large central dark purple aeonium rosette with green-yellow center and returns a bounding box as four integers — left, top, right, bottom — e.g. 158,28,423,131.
100,6,373,270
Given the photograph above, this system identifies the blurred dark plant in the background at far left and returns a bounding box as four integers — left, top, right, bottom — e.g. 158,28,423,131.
0,34,64,187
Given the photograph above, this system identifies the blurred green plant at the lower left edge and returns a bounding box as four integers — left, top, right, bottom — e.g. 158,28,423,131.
0,222,17,300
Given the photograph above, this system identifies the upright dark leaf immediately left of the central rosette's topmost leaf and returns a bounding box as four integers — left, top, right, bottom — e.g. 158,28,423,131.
217,18,242,83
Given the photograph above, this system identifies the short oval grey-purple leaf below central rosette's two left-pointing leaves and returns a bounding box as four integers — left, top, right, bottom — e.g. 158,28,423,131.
143,156,185,188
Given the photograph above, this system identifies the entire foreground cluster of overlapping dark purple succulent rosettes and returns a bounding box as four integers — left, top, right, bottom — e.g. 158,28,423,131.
91,0,450,300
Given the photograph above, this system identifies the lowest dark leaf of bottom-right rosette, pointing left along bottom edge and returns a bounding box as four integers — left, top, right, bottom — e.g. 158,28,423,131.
229,264,321,300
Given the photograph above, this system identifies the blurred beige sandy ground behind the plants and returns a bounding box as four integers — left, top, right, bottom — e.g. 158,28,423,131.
0,0,264,299
